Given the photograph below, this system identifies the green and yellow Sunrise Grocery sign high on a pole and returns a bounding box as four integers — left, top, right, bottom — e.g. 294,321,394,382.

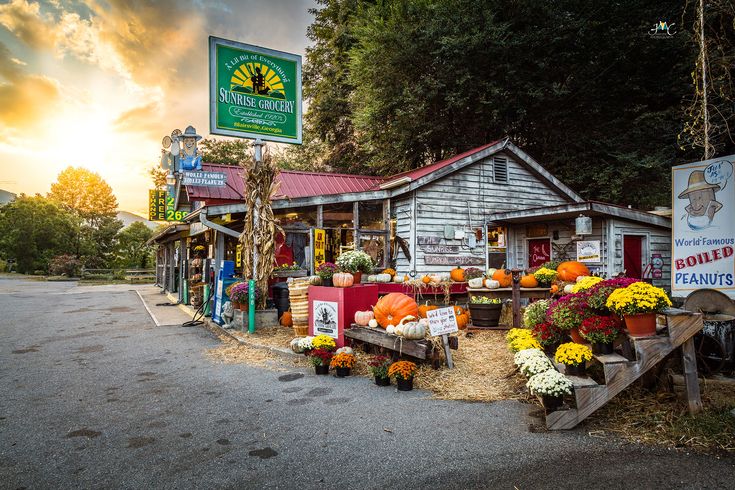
209,36,302,144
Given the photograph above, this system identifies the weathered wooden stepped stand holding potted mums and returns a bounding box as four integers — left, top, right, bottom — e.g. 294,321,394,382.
546,309,703,430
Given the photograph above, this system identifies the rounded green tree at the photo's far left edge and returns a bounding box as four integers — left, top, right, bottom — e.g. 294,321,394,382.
0,194,80,273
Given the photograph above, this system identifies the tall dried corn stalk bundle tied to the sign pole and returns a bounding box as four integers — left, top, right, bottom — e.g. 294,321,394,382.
240,145,282,309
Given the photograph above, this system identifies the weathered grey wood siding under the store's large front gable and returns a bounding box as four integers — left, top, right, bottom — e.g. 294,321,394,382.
395,153,570,275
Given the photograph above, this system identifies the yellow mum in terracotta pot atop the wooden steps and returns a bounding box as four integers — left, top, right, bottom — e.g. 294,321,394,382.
605,282,671,337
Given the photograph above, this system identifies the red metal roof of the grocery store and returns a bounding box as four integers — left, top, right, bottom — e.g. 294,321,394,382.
186,140,500,204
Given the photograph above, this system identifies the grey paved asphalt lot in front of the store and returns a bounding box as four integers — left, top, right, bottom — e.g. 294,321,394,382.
0,278,735,489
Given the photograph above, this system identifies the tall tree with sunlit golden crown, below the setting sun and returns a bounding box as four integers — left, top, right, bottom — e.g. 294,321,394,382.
48,167,123,268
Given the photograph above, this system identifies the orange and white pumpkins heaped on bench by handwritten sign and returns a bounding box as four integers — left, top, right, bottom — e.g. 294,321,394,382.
355,293,470,340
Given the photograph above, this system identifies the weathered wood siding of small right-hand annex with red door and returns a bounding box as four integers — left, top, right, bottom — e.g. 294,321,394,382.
610,219,671,291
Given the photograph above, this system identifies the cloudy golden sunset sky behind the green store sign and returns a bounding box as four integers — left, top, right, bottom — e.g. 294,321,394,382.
0,0,314,215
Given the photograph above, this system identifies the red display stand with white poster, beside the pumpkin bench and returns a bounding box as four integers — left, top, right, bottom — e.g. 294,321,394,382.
309,284,378,347
